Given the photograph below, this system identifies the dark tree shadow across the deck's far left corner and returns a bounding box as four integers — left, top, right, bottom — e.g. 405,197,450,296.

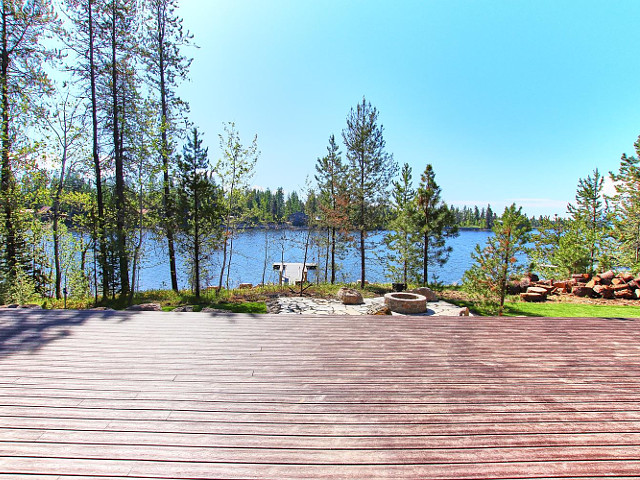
0,308,135,358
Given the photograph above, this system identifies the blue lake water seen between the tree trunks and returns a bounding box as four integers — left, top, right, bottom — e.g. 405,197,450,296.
132,229,491,290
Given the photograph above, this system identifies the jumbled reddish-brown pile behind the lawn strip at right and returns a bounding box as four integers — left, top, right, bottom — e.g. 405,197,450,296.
509,270,640,302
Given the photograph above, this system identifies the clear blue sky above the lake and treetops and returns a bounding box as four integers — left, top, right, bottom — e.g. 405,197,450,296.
179,0,640,216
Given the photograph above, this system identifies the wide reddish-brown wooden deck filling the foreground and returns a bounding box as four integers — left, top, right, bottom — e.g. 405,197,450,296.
0,311,640,480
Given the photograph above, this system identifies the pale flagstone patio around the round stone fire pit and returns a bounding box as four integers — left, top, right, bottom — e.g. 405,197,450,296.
278,297,470,317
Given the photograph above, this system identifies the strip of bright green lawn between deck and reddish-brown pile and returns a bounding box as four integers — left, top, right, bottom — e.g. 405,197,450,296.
504,302,640,318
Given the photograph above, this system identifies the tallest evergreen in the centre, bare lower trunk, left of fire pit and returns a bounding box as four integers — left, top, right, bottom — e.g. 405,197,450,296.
342,97,397,288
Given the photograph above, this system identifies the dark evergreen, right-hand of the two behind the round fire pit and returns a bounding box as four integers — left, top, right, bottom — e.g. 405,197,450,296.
416,164,460,286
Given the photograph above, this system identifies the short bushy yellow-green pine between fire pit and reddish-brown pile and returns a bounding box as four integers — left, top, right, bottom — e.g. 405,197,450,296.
463,204,531,315
